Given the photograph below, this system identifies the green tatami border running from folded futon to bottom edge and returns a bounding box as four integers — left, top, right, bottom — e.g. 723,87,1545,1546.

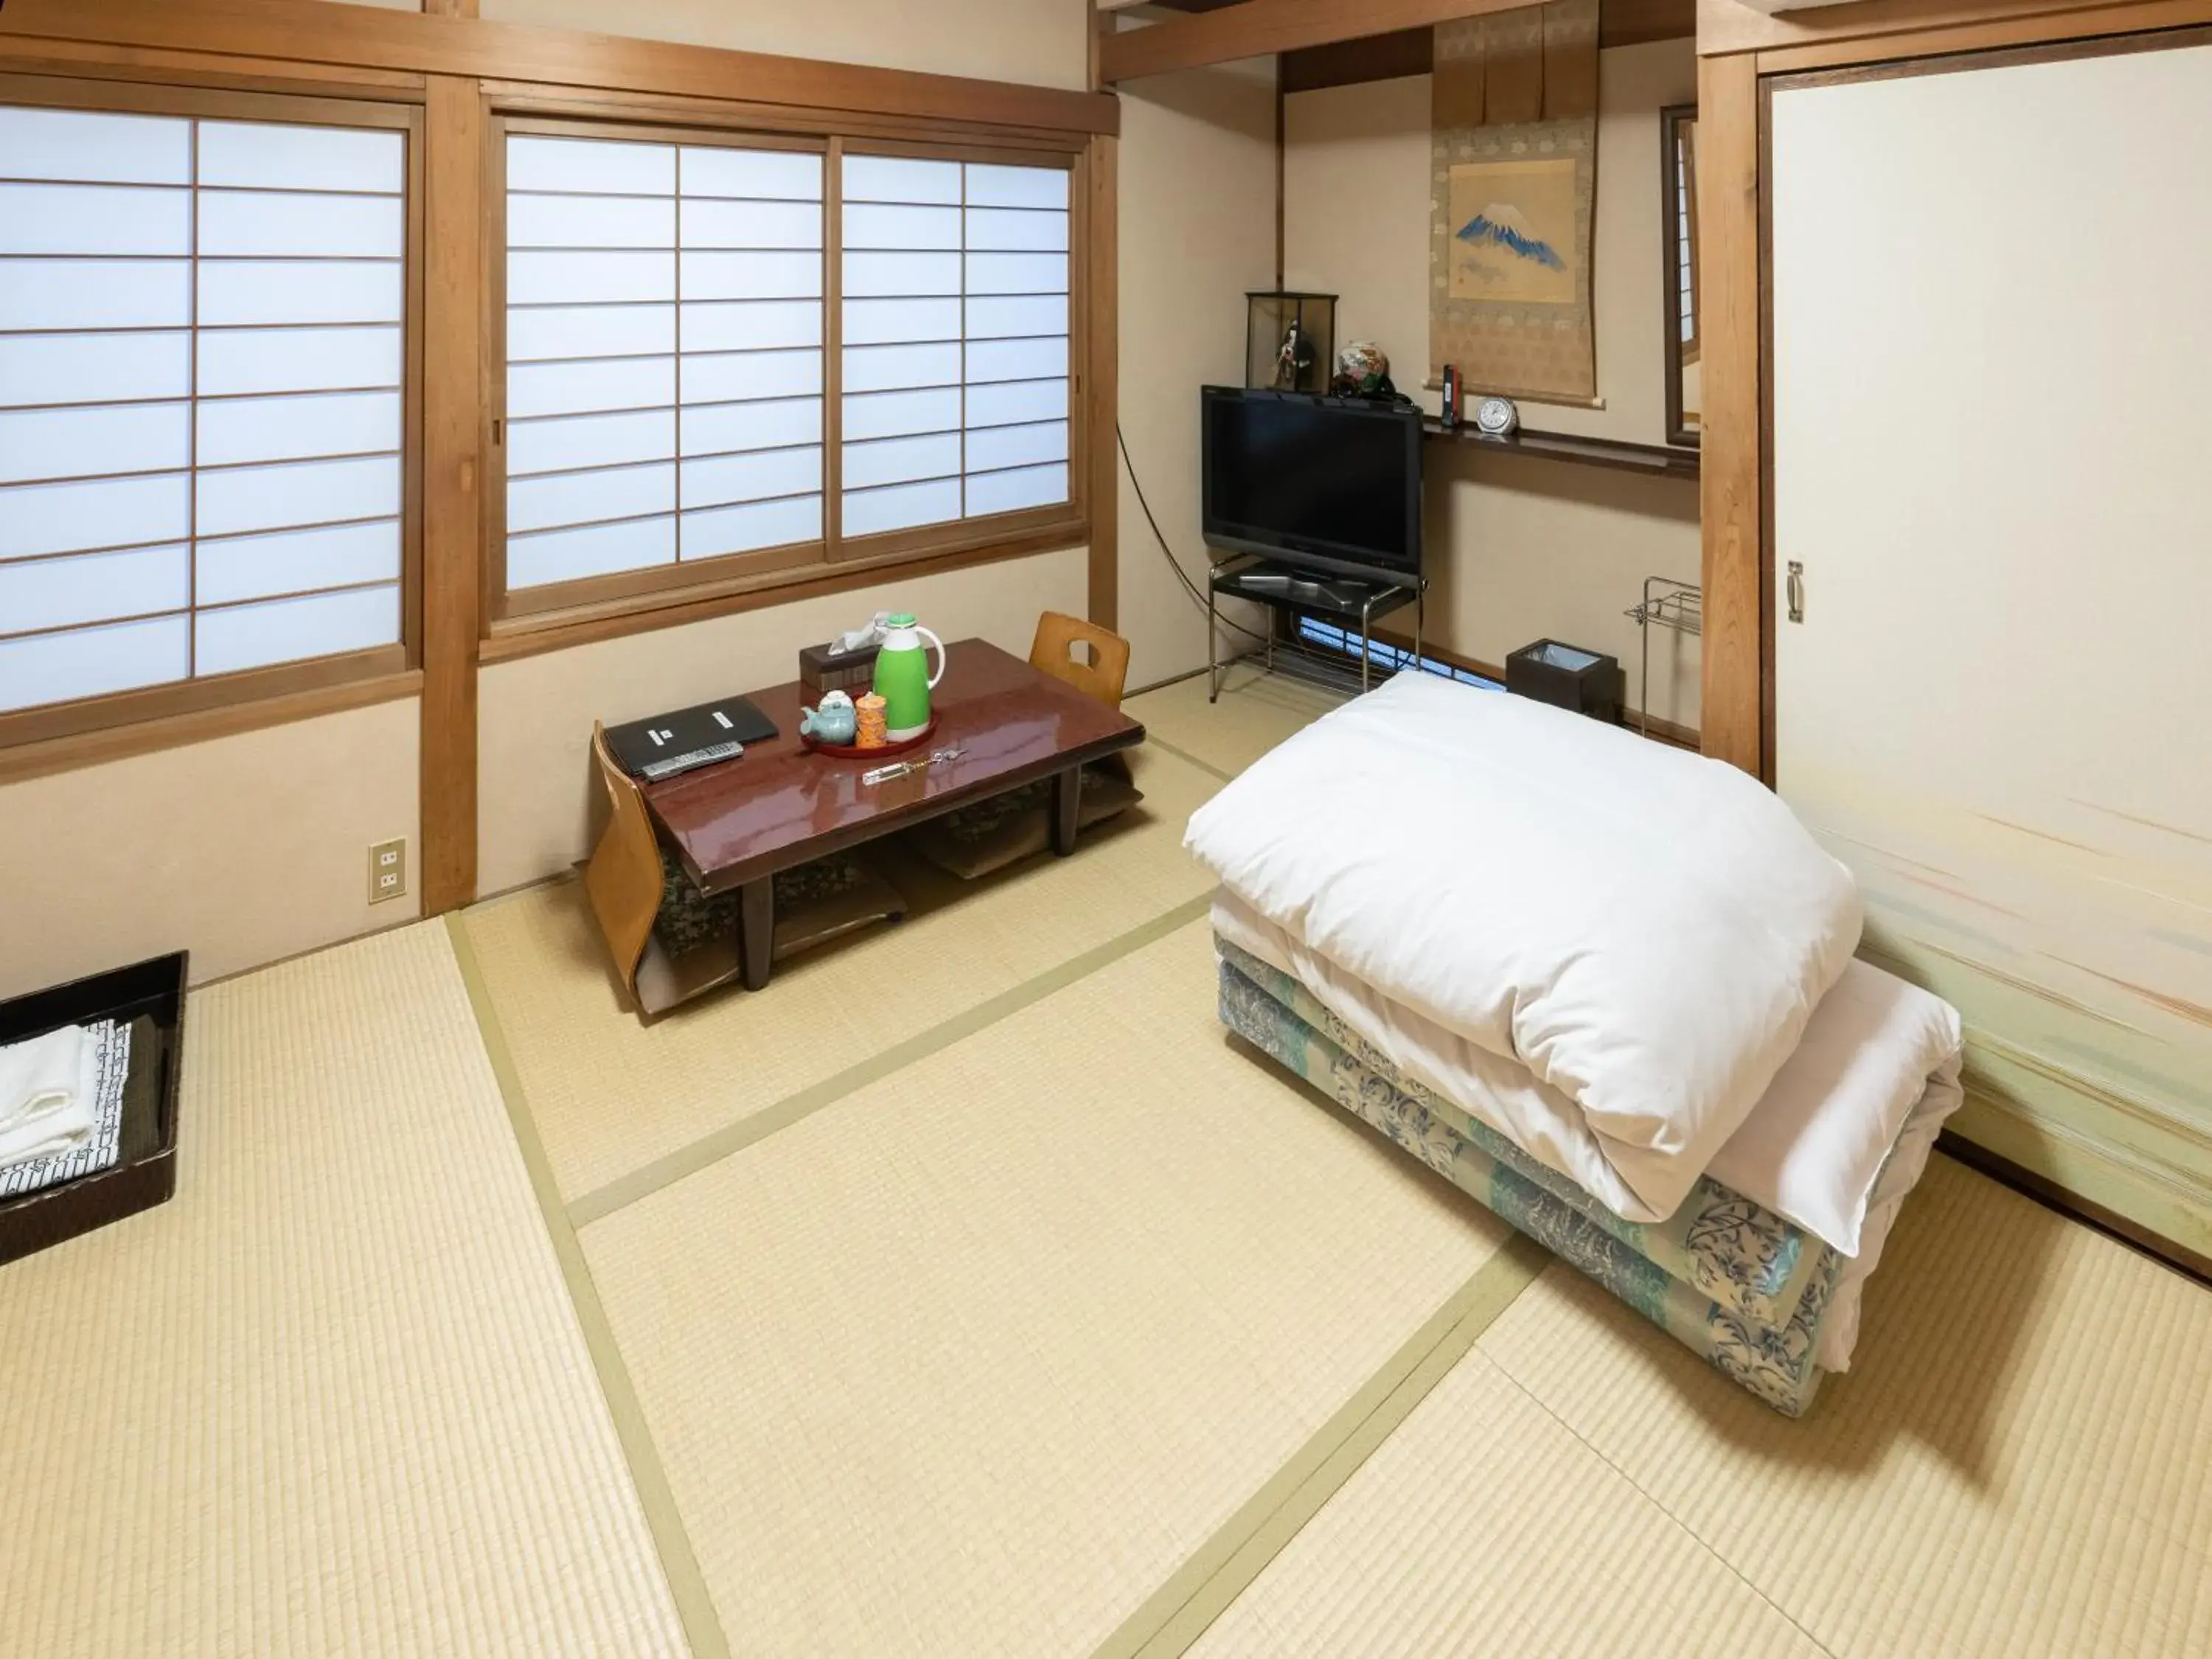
1093,1232,1553,1659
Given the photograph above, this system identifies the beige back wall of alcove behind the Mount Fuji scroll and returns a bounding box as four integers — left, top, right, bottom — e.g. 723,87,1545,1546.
1285,40,1701,726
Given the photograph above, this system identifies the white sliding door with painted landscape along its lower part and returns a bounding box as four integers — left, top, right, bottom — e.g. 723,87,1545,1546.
1761,31,2212,1261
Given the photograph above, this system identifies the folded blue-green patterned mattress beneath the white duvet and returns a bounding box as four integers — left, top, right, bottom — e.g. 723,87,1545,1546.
1214,936,1843,1418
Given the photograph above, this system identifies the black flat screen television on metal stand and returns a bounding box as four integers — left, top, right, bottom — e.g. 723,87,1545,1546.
1199,385,1422,575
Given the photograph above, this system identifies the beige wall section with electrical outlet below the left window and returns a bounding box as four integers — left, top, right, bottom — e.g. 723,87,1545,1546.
0,697,422,998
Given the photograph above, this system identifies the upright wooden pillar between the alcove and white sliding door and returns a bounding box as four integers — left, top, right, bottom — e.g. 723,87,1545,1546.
1697,53,1772,779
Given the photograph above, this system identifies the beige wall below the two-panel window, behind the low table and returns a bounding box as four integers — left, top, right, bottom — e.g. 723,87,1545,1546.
478,549,1088,894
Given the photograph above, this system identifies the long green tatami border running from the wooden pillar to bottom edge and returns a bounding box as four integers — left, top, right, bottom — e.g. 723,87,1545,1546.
445,911,730,1659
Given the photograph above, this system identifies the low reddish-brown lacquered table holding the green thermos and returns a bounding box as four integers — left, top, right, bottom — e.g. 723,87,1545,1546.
646,639,1144,991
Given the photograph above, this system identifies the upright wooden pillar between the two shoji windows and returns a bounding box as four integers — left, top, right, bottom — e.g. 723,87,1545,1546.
422,74,484,916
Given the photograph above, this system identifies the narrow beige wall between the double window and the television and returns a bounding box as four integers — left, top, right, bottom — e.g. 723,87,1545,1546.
1119,60,1276,686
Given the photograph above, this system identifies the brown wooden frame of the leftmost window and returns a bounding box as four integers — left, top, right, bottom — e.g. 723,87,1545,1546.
0,73,425,761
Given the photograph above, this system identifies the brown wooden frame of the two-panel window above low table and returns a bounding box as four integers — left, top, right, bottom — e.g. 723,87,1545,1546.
482,82,1093,661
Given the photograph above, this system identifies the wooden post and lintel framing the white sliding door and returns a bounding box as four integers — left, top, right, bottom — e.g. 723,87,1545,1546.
1697,0,2212,785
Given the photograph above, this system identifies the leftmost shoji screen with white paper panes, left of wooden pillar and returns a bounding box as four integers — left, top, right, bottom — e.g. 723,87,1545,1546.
0,106,407,712
